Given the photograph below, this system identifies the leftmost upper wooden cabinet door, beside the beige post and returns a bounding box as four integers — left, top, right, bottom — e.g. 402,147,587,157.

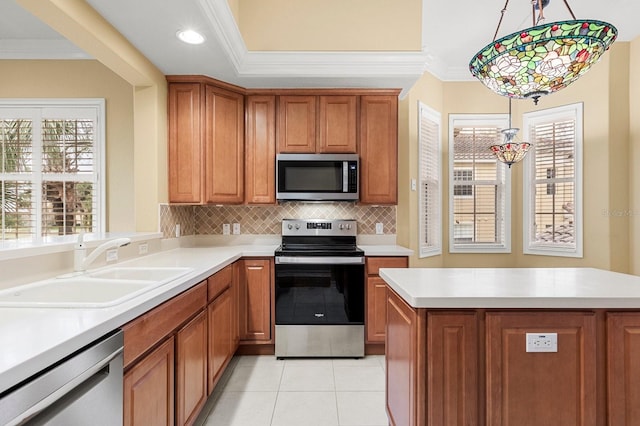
168,83,204,203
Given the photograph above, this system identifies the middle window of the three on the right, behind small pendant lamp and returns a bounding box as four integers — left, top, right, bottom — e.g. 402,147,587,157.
449,114,511,253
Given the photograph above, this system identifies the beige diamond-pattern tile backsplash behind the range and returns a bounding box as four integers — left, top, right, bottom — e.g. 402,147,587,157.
160,202,396,238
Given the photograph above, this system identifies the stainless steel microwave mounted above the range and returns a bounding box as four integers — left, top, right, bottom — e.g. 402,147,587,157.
276,154,360,201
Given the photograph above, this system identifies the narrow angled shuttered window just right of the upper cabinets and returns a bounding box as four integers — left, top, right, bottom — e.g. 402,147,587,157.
418,102,442,257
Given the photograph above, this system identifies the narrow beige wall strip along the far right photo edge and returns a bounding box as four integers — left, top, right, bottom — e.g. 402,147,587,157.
629,37,640,275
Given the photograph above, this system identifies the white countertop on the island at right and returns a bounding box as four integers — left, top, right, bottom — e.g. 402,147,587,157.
380,268,640,309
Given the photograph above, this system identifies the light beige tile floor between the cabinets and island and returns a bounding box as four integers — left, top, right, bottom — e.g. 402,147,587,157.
196,355,389,426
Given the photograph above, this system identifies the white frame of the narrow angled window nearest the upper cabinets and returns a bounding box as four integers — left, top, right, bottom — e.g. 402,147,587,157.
418,101,443,258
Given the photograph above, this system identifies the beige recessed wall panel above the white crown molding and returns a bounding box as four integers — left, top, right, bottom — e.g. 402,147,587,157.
238,0,422,51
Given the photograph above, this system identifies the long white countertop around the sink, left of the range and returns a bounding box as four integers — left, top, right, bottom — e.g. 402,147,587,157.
0,245,277,392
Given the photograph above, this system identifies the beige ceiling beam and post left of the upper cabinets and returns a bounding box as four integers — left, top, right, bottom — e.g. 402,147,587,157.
16,0,168,231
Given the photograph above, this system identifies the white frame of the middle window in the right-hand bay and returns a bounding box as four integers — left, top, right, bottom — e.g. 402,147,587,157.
448,114,511,254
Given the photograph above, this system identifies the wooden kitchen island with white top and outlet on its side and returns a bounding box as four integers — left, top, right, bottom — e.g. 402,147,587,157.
380,268,640,426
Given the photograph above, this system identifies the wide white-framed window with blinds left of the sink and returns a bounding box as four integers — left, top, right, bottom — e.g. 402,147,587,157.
0,99,104,242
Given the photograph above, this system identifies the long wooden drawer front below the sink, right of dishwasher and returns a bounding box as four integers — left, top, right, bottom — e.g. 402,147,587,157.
123,281,207,368
